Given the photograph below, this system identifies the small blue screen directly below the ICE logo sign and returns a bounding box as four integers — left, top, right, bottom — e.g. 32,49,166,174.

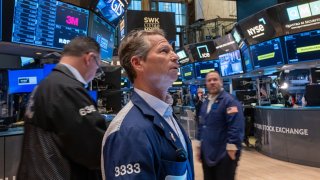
194,60,220,79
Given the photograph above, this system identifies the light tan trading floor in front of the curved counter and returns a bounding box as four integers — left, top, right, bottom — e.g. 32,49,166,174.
193,141,320,180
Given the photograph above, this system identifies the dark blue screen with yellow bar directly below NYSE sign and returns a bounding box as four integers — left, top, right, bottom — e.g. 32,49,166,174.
250,38,283,69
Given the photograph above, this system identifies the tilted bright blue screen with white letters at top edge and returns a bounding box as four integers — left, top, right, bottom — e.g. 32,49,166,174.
95,0,130,26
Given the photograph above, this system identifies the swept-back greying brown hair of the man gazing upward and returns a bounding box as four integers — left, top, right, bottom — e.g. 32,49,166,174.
118,29,165,83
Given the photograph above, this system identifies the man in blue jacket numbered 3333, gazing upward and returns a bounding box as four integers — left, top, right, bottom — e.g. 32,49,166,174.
102,29,194,180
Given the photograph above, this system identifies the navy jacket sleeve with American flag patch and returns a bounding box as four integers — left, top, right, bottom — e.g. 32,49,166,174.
226,97,244,150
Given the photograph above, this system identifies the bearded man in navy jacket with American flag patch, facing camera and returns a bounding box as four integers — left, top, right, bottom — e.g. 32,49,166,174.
198,71,244,180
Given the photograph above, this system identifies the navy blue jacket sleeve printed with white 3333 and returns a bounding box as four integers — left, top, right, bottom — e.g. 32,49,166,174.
102,124,156,180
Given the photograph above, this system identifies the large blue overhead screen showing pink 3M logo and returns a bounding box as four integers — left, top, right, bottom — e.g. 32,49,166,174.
11,0,89,49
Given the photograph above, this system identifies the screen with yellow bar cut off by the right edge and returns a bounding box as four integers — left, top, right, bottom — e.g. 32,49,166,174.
284,30,320,64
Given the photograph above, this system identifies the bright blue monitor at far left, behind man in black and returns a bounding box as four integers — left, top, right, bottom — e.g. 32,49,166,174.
8,69,43,94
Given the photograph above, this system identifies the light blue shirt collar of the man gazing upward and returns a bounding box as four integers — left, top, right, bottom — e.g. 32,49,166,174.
134,88,173,116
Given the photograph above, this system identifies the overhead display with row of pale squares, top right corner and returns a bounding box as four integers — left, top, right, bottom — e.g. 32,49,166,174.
278,0,320,34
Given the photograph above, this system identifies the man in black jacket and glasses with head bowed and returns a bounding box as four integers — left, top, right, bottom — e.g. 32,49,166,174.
17,37,107,180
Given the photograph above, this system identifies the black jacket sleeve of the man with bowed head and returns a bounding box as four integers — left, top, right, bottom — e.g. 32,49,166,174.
49,87,106,169
